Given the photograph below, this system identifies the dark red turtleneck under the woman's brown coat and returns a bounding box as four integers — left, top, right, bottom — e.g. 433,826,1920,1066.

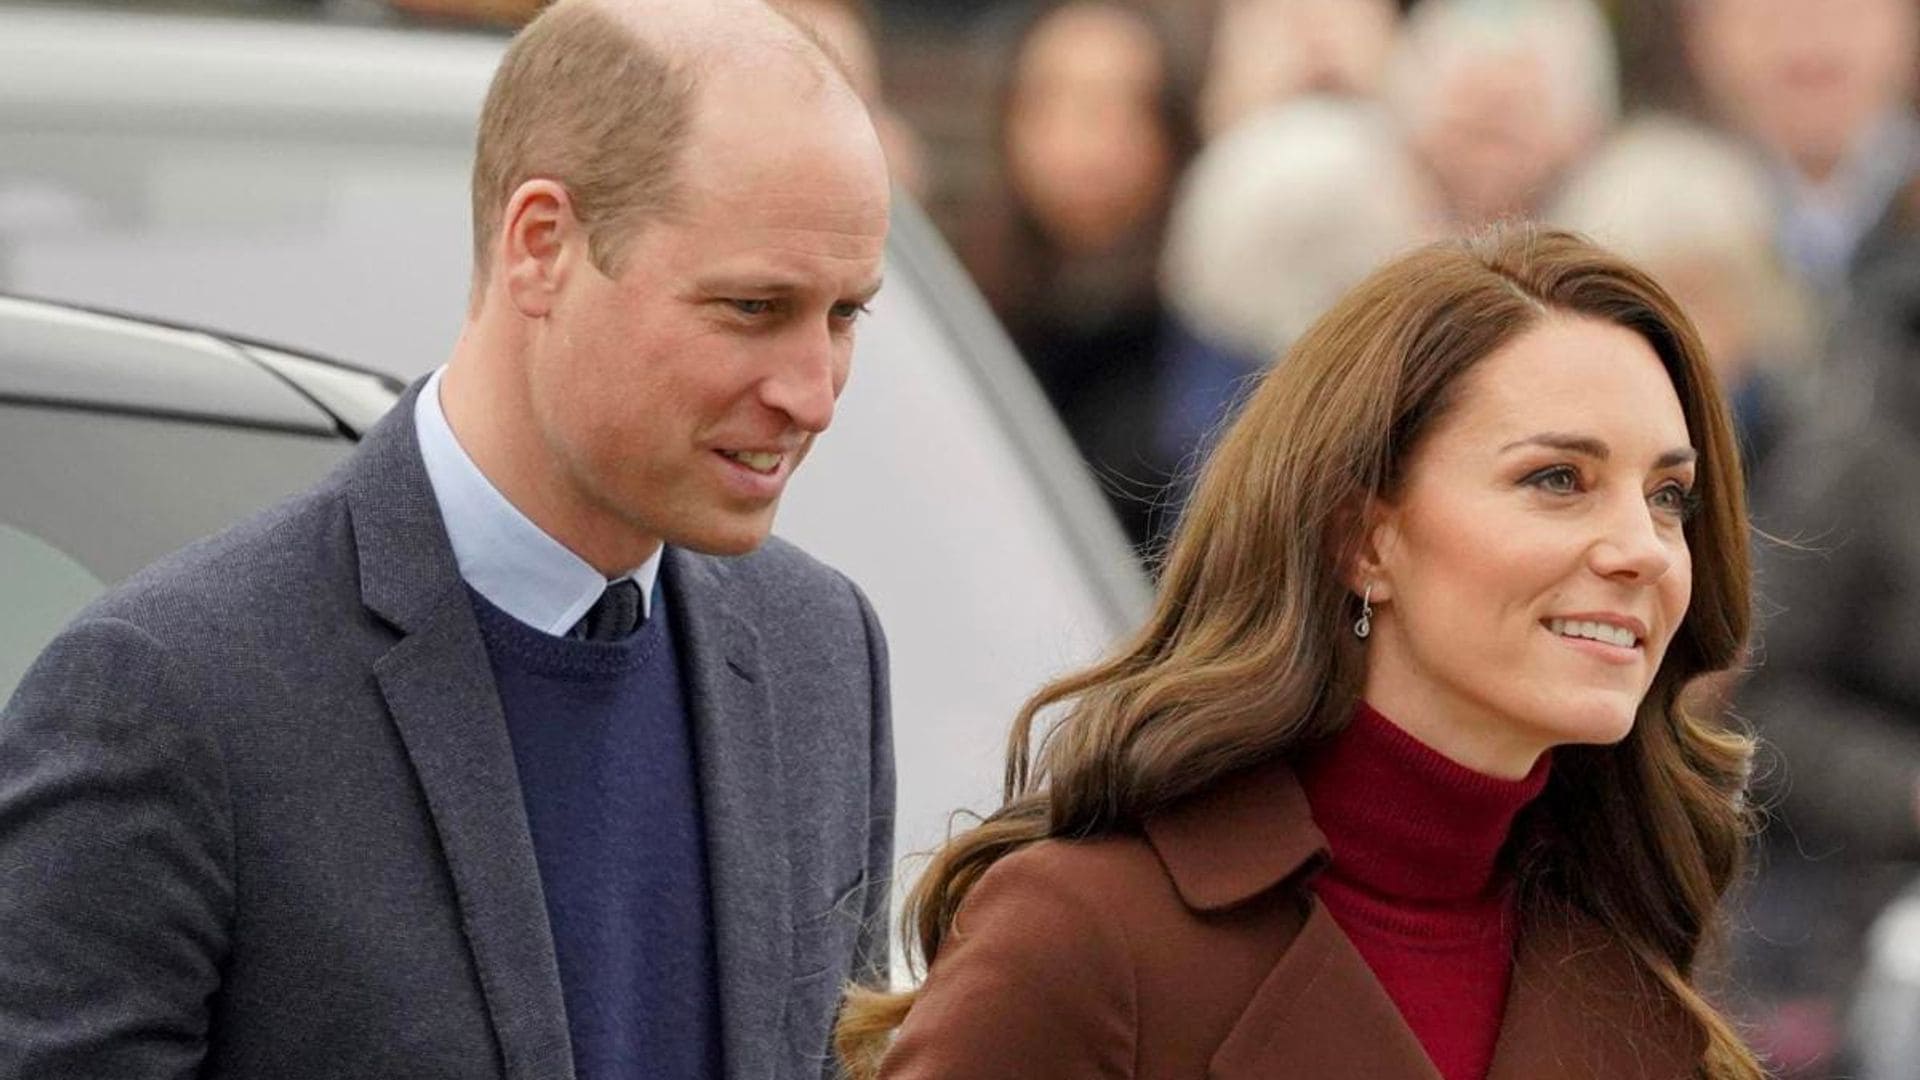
1300,703,1548,1080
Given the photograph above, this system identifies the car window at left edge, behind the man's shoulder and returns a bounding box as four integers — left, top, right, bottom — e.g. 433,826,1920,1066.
0,404,353,700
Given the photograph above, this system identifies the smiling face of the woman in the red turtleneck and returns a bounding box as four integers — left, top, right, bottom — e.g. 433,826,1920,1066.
1356,315,1695,776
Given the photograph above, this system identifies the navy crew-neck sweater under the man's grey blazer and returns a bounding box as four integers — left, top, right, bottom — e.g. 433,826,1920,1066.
468,590,722,1080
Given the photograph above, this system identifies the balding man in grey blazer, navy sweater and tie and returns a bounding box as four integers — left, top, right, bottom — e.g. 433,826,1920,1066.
0,0,893,1080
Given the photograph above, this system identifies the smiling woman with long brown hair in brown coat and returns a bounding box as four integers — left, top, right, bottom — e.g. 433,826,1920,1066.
839,229,1763,1080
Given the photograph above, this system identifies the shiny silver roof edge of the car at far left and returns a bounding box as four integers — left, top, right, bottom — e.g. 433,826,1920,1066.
0,294,401,438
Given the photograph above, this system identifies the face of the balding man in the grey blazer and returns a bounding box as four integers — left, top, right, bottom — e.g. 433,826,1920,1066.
526,71,887,555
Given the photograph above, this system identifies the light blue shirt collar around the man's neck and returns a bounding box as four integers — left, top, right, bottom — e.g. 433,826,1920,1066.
413,367,660,634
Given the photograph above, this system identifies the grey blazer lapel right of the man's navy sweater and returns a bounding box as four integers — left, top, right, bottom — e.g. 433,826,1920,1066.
662,548,793,1078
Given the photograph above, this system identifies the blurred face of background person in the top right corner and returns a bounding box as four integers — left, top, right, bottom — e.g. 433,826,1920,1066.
1688,0,1920,177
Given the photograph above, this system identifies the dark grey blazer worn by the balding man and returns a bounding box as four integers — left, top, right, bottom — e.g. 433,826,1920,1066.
0,390,893,1080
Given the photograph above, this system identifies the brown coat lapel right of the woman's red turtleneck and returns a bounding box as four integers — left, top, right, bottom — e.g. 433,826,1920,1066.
1486,899,1703,1080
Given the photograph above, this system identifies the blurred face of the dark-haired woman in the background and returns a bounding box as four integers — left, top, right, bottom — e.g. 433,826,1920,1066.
1006,4,1173,254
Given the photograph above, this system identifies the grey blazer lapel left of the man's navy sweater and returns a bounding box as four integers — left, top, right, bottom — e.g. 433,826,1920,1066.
348,384,574,1080
